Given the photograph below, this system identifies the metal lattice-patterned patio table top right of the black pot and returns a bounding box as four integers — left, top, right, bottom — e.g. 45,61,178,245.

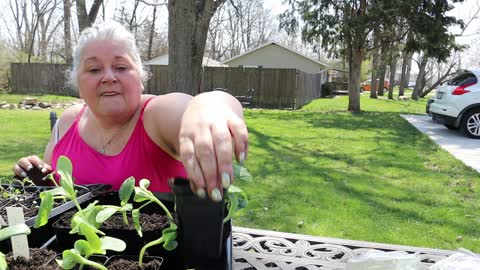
232,226,454,270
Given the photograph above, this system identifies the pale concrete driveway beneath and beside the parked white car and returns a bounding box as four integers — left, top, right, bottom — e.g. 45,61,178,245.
400,115,480,172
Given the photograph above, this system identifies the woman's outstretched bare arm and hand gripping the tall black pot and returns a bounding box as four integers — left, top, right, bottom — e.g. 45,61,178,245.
144,91,248,201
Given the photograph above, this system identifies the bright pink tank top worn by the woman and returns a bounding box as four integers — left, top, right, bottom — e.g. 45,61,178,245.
52,99,187,192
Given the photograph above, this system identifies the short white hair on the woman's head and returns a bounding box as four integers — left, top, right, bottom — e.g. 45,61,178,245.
67,21,150,88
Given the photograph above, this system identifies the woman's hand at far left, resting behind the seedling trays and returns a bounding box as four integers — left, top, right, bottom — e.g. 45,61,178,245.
13,155,52,184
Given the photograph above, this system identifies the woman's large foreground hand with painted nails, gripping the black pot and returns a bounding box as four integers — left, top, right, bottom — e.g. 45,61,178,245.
179,92,248,201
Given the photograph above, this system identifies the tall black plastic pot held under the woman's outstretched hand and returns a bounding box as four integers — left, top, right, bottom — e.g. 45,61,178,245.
172,178,231,269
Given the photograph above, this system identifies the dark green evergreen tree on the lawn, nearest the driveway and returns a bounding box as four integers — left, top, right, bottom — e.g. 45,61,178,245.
280,0,461,112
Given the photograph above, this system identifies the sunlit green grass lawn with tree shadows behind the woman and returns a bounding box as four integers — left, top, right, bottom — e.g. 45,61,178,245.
0,95,480,252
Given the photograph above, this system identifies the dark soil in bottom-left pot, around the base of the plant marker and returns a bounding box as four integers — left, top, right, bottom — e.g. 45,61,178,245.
6,248,61,270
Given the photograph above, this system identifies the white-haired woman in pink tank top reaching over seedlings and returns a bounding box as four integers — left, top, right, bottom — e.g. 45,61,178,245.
13,23,248,201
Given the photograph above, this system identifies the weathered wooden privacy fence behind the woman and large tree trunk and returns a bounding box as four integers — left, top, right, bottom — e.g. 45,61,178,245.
11,63,328,109
